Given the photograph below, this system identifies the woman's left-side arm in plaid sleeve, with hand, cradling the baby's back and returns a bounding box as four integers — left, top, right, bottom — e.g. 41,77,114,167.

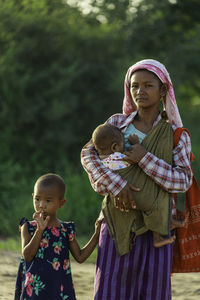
81,114,139,211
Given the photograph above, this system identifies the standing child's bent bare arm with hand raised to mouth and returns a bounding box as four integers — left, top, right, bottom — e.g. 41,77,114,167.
21,213,49,262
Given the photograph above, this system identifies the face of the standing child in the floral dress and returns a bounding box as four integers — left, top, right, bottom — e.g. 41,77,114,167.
33,183,65,218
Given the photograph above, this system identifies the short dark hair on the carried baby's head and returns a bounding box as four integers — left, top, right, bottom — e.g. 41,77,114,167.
92,124,124,146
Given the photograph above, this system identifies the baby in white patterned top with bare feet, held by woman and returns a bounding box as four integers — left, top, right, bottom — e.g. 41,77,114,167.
92,124,184,248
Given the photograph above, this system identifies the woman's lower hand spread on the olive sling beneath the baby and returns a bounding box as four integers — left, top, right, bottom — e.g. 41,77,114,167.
114,183,140,212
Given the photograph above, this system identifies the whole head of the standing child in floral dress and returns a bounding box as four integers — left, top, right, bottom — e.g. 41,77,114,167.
33,173,66,215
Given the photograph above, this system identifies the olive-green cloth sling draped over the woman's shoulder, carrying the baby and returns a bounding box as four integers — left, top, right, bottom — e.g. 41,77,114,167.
102,119,173,255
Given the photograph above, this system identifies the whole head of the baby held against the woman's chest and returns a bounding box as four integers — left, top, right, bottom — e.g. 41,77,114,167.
92,124,124,155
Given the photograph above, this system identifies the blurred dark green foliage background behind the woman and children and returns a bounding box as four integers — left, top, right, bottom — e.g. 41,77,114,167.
0,0,200,238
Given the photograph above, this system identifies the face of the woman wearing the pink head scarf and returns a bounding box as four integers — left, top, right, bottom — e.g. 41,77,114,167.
130,70,163,110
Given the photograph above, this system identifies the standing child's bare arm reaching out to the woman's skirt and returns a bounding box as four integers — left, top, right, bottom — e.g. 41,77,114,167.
69,220,102,264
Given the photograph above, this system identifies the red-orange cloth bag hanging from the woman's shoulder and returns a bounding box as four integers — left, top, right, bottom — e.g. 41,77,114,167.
172,128,200,273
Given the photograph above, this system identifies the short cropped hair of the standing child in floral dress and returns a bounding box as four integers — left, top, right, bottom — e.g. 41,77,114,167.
35,173,65,198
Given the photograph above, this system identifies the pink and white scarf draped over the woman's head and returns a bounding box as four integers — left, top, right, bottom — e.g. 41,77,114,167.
123,59,183,127
